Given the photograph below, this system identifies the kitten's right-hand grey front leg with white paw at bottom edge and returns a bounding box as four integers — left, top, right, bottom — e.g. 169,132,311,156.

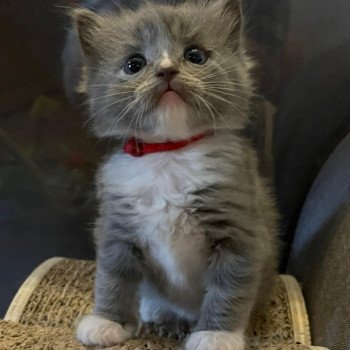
185,238,258,350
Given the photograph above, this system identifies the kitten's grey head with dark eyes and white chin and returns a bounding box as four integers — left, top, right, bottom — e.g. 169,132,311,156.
74,0,252,140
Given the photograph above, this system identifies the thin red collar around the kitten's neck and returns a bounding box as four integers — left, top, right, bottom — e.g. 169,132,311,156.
123,133,207,157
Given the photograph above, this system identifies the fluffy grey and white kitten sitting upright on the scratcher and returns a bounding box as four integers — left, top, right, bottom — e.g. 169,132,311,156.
66,0,276,350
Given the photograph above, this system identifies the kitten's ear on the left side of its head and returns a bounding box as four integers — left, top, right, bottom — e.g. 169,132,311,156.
71,9,102,60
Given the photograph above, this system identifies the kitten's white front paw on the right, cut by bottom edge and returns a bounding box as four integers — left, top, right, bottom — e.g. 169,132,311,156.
185,331,245,350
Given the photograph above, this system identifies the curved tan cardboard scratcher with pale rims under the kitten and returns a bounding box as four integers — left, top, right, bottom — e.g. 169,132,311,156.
0,258,322,350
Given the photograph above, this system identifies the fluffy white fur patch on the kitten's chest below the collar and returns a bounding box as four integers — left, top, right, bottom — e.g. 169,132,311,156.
101,145,217,292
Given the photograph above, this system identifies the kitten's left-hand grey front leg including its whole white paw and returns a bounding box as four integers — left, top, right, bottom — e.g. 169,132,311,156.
77,242,141,347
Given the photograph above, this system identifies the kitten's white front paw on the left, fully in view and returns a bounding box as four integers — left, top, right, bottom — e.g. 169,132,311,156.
76,315,135,347
